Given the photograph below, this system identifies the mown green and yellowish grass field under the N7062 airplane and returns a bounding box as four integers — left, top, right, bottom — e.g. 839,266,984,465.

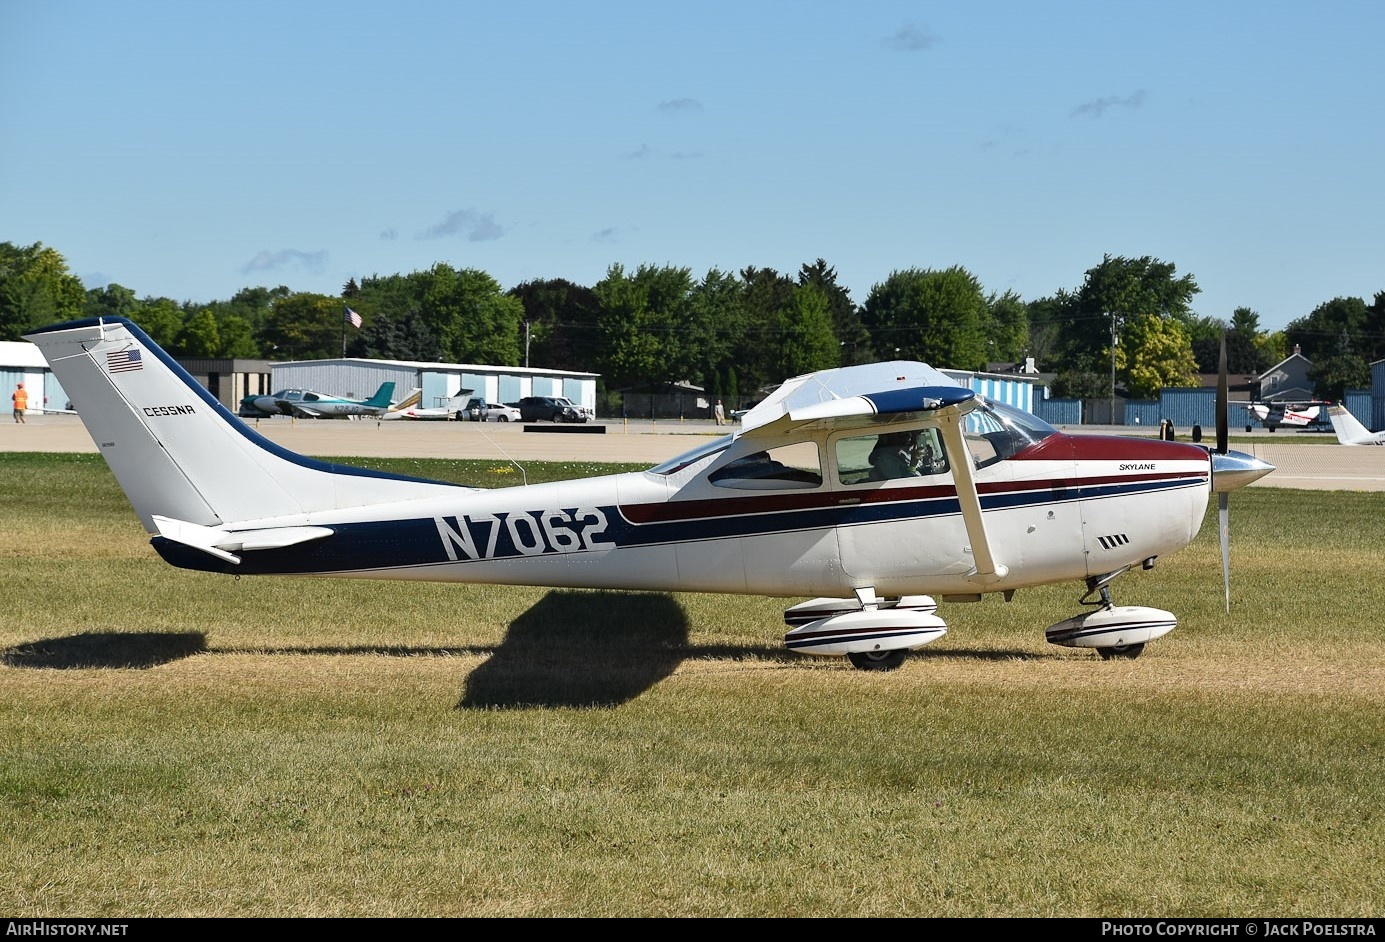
0,453,1385,917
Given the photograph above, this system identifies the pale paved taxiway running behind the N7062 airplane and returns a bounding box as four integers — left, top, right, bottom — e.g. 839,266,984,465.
0,414,1385,490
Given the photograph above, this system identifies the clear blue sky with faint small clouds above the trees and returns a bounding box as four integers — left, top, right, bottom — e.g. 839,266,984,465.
0,0,1385,330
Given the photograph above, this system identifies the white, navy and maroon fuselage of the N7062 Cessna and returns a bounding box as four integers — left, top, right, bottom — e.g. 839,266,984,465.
154,435,1209,597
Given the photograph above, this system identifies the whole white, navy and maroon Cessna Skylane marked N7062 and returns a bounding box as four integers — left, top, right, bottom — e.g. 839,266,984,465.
26,317,1274,670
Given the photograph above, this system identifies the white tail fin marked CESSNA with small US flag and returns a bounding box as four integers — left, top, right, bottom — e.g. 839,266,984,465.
25,317,456,533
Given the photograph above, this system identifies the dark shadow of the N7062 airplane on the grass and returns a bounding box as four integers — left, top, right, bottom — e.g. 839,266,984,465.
0,590,1035,709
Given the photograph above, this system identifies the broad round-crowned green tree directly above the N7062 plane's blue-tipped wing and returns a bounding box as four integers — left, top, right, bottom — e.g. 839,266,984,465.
863,266,989,370
